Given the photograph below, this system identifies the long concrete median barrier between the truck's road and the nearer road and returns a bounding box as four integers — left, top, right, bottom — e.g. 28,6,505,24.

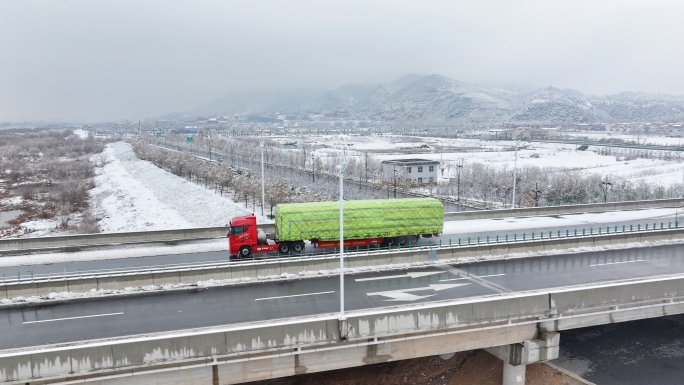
0,228,684,298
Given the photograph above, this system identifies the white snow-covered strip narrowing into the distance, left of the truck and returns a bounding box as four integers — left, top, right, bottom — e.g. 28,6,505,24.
91,142,269,232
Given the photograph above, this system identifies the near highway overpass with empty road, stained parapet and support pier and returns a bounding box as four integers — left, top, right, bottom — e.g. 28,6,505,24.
0,245,684,385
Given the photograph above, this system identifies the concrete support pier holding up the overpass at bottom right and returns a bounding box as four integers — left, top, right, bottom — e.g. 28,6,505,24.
485,332,560,385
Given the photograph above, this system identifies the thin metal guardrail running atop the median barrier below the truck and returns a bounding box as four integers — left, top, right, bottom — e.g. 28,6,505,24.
0,222,684,287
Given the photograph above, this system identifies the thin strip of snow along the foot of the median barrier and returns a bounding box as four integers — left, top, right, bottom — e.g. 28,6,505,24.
0,239,684,306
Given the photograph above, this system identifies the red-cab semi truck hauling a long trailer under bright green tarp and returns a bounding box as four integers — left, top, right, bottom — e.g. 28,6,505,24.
227,198,444,258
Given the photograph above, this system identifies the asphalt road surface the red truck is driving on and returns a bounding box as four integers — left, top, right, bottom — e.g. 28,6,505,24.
0,209,684,279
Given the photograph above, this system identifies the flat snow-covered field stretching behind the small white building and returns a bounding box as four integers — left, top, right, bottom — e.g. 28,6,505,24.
310,133,684,186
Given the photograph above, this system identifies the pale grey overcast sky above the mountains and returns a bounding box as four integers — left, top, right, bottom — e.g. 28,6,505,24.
0,0,684,121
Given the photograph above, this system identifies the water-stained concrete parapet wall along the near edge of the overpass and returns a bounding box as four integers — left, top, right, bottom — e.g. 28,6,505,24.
0,276,684,385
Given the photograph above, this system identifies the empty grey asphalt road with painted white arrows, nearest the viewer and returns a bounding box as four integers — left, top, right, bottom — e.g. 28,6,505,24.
0,245,684,349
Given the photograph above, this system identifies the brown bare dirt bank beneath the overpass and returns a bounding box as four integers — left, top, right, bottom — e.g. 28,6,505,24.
251,350,584,385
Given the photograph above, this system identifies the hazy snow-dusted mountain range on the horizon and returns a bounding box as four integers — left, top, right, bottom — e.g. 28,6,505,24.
164,74,684,123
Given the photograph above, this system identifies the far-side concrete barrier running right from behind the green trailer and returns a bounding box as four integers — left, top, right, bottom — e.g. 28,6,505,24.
444,198,684,221
